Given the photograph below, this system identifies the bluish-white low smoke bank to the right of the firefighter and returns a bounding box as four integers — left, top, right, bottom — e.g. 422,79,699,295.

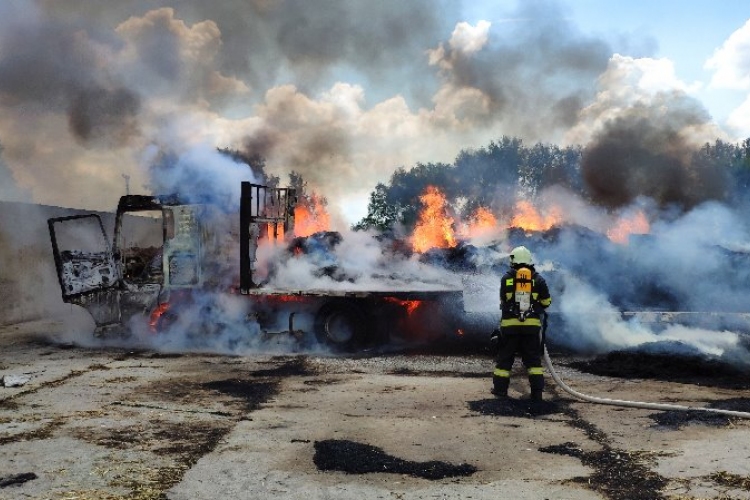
488,192,750,366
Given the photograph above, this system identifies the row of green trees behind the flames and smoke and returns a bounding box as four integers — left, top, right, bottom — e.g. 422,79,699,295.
353,136,750,232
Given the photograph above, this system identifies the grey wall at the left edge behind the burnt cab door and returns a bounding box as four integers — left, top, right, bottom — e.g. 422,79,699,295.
0,201,114,325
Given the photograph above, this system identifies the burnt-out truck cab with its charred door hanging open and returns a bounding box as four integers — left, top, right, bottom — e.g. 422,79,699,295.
47,195,204,335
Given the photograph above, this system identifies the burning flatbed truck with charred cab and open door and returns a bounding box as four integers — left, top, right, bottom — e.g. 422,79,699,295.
48,182,465,351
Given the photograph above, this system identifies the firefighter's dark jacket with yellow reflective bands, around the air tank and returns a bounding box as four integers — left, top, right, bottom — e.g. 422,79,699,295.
500,265,552,332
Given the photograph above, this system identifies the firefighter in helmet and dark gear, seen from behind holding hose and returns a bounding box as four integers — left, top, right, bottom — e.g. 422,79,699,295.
490,246,552,401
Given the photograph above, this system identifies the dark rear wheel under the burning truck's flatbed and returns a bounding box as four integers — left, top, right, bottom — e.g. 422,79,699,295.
315,302,368,351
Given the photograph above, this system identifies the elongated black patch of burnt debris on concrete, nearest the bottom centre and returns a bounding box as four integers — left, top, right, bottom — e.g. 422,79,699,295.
313,439,477,480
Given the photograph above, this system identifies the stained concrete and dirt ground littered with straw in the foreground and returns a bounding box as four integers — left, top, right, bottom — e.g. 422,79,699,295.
0,322,750,500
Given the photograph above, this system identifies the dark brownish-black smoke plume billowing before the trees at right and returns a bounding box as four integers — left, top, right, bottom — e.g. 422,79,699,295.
581,95,727,209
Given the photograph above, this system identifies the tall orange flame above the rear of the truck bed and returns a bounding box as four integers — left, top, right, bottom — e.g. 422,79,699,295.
412,186,456,252
